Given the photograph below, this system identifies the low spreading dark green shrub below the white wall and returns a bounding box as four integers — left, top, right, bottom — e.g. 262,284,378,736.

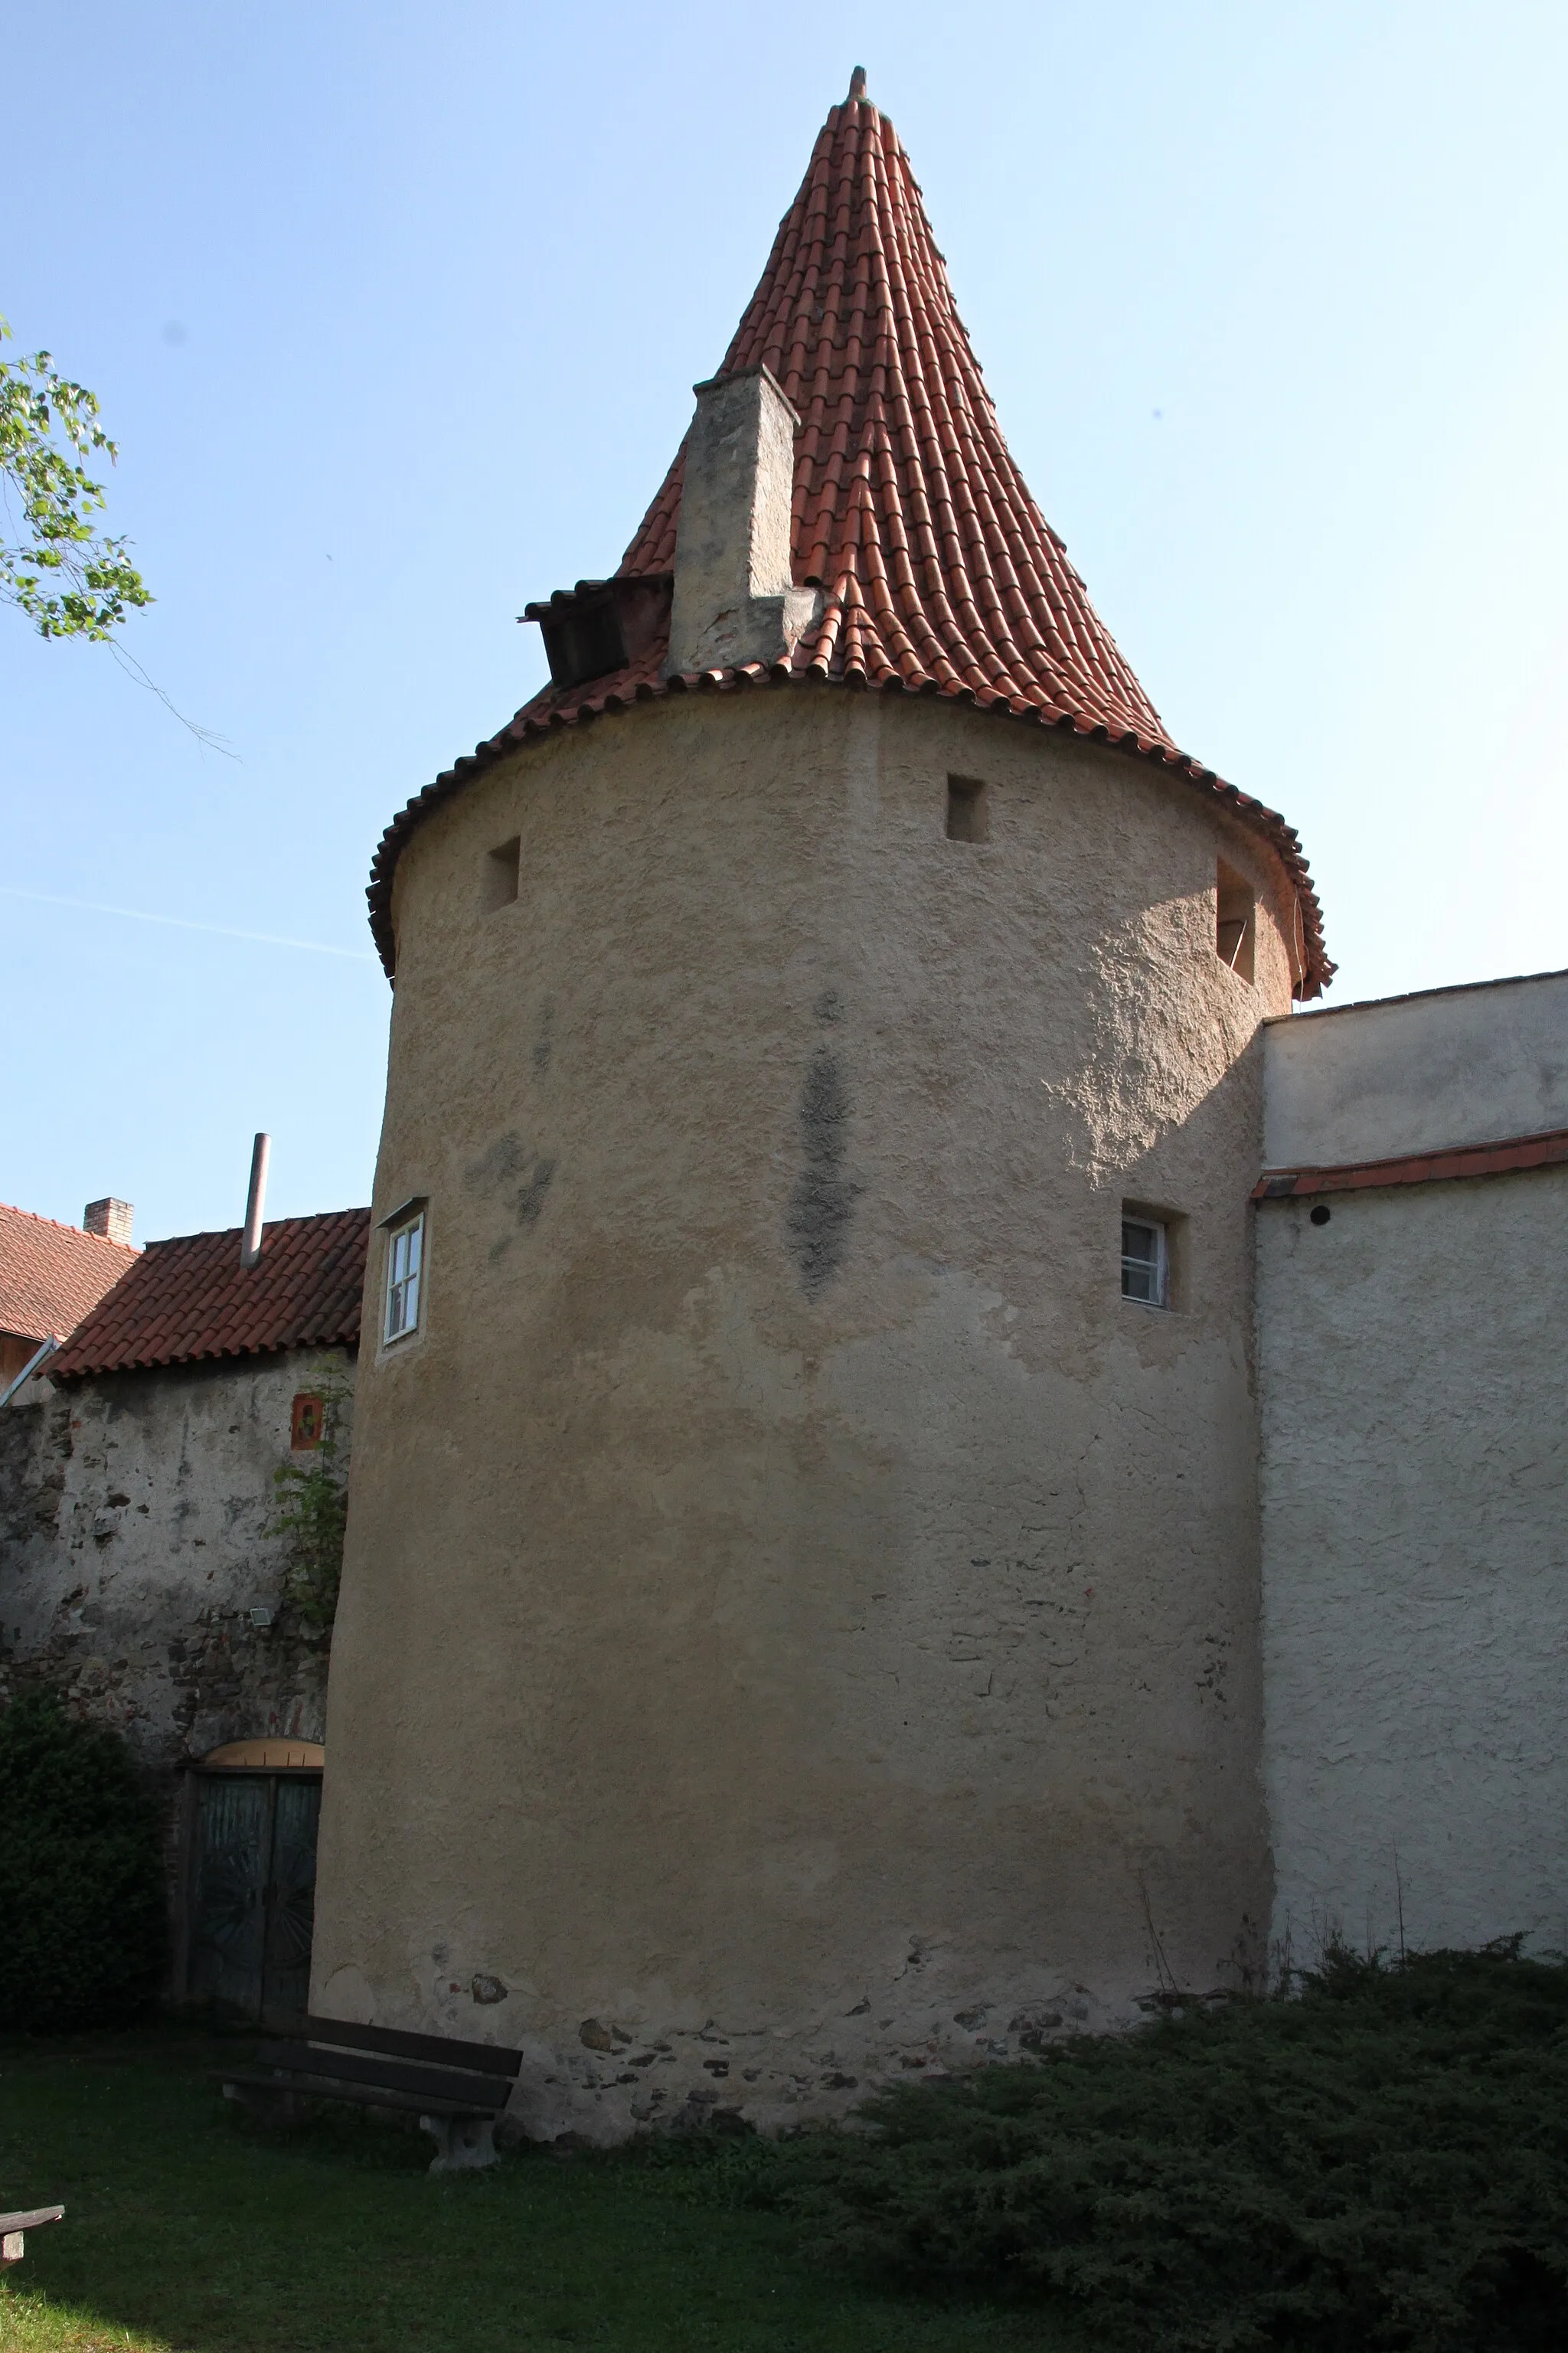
714,1943,1568,2353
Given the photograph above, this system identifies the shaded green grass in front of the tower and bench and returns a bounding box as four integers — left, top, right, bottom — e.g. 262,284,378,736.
0,2028,1088,2353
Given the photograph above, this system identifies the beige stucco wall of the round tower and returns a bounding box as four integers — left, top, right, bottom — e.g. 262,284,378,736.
313,689,1288,2139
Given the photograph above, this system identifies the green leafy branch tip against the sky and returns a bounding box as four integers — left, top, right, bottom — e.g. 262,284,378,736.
0,318,153,645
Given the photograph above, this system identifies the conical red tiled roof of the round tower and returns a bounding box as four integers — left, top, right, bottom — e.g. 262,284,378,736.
368,73,1335,998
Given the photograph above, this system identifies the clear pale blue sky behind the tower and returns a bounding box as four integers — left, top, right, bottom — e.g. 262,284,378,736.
0,0,1568,1237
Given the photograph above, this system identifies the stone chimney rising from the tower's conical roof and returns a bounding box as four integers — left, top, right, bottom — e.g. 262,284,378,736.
664,367,822,678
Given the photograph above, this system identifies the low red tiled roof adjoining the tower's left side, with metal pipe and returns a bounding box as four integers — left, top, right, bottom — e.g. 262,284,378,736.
50,1210,370,1379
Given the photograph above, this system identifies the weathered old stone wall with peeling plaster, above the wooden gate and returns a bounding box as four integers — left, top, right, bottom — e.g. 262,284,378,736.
0,1351,353,1772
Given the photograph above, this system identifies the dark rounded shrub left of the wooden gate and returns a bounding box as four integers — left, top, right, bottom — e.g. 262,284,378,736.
0,1691,167,2033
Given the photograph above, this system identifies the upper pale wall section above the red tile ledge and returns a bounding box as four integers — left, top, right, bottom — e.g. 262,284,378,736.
1264,972,1568,1167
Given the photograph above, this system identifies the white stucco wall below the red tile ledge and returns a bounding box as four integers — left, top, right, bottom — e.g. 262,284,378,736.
1257,1176,1568,1965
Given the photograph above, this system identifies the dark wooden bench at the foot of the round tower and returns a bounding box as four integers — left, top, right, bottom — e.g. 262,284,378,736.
219,2019,523,2174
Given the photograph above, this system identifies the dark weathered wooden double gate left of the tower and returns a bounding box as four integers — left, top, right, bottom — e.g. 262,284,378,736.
184,1741,320,2026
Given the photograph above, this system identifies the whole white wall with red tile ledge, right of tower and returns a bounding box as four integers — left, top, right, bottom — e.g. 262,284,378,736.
1257,972,1568,1962
